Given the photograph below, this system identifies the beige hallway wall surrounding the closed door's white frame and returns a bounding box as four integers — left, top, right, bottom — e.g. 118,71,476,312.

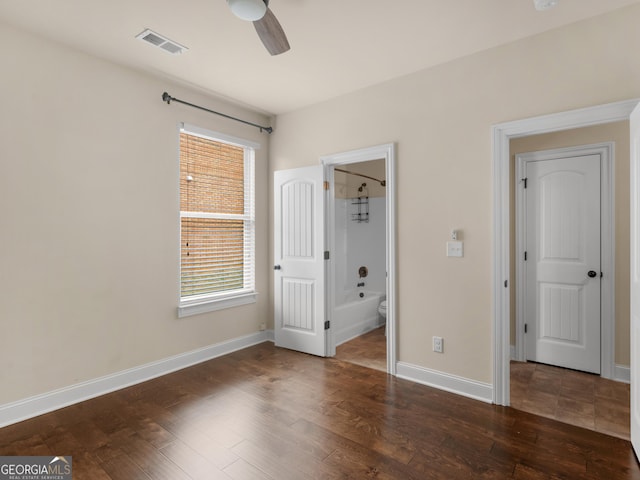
510,121,630,366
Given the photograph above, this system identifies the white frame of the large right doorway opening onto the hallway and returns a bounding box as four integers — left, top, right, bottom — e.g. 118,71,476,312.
491,99,639,406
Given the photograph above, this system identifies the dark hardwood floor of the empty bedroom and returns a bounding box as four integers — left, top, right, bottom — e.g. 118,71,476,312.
0,343,640,480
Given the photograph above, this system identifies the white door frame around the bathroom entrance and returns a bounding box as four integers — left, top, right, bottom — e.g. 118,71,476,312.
320,143,397,375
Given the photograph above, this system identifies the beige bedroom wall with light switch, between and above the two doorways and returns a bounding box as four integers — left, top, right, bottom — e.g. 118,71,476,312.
270,5,640,382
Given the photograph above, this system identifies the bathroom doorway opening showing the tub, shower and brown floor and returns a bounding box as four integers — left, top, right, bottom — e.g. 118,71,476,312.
331,159,387,372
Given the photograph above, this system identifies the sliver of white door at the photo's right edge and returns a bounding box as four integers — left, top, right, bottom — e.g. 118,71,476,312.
630,105,640,456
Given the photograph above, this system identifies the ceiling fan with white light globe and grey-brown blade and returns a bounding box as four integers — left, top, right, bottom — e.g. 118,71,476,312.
227,0,291,55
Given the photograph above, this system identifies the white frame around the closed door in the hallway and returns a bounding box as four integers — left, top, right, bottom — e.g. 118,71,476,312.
514,142,616,379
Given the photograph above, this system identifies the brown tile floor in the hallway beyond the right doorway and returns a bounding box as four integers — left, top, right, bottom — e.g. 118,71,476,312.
511,362,630,440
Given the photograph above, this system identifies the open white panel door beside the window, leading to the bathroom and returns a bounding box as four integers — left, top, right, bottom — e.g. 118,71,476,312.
274,165,326,356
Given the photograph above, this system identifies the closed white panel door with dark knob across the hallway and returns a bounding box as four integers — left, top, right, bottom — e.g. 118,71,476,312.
525,155,601,373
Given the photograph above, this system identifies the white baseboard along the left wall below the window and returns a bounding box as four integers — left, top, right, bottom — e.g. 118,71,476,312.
0,330,273,427
